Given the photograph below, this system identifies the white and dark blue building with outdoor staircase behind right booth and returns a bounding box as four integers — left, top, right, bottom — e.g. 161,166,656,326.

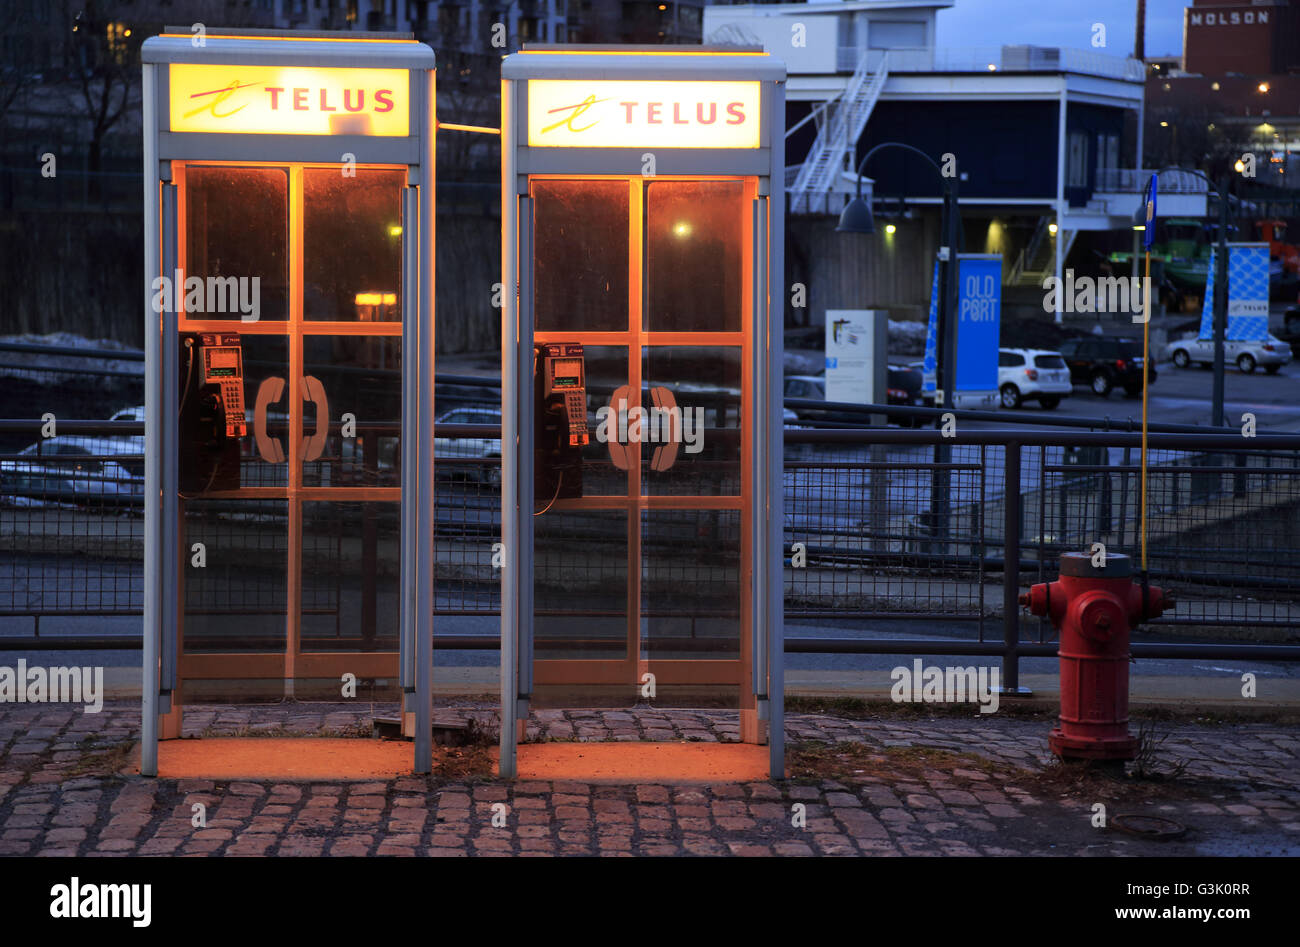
705,0,1205,324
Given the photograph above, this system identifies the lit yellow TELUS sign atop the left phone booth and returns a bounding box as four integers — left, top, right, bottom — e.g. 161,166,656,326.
169,62,411,138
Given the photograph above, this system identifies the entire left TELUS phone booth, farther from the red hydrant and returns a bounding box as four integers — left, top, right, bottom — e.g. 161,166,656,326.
142,27,436,775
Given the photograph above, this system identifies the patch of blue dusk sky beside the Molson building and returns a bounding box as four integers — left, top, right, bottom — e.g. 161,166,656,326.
939,0,1191,56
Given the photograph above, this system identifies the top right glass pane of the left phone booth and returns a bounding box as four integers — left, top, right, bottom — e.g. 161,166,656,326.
303,168,406,323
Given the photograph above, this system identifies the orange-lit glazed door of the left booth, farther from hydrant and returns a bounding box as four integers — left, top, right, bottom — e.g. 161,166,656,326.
173,161,406,699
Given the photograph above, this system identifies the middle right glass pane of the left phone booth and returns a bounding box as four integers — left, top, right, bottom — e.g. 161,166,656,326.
303,336,402,487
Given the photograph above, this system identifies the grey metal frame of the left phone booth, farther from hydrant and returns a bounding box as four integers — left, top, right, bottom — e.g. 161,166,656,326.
140,27,437,775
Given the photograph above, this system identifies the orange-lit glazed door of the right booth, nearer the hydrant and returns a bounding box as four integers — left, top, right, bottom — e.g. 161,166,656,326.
525,177,757,708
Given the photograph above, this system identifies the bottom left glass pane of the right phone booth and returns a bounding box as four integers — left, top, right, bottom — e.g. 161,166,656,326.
533,510,632,658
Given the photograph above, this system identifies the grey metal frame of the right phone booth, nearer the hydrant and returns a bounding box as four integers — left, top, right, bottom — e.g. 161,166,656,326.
499,46,785,778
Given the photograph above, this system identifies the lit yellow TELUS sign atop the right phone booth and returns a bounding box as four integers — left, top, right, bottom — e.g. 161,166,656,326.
528,79,762,148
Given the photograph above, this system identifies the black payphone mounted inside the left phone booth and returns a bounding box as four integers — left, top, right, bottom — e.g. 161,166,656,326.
178,332,248,494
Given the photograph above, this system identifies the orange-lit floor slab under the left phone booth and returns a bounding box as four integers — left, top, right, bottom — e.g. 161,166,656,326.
134,736,408,782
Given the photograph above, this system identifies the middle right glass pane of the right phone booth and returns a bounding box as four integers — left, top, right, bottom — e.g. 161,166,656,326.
639,346,742,497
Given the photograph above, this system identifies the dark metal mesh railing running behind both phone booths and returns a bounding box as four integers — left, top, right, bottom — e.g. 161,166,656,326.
0,411,1300,687
